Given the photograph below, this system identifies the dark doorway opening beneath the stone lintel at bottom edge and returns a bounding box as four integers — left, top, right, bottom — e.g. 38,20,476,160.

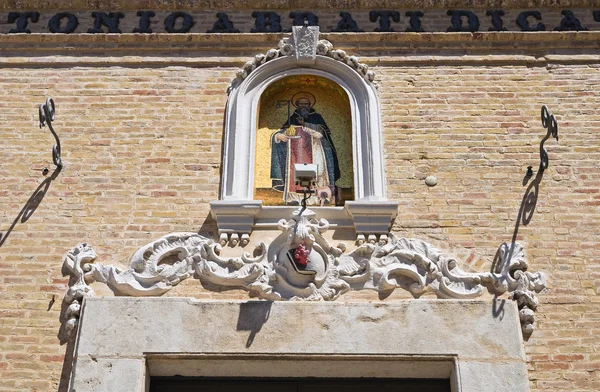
150,377,450,392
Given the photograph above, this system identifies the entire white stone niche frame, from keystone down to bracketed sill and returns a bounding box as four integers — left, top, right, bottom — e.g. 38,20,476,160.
211,27,398,245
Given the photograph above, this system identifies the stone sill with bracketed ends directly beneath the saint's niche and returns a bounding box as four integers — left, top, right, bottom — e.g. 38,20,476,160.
210,200,399,245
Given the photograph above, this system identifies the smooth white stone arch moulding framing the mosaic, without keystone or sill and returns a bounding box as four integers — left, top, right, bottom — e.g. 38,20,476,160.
221,56,386,201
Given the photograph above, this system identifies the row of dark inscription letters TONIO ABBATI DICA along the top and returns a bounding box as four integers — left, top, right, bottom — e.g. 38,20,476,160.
0,9,600,34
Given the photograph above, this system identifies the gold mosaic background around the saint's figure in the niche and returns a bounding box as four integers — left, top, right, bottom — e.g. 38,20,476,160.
254,75,354,193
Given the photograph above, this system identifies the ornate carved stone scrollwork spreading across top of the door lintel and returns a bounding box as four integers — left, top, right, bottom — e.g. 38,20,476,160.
64,210,546,333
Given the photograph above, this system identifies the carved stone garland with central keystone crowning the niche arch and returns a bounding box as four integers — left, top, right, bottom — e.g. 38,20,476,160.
227,26,375,94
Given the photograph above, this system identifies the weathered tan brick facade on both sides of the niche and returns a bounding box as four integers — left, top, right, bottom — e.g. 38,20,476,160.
0,1,600,392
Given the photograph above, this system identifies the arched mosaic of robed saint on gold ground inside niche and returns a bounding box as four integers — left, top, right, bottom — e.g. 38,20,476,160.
255,75,354,206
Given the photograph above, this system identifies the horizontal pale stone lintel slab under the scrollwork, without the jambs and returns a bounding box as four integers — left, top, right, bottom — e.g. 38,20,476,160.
77,297,525,363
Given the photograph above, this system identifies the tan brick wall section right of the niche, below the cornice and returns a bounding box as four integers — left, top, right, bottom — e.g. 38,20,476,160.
378,64,600,391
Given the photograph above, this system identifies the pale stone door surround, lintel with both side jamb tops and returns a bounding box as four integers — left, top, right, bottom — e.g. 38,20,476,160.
71,297,529,392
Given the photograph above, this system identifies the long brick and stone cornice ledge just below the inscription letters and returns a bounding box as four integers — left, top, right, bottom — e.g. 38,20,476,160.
0,31,600,67
